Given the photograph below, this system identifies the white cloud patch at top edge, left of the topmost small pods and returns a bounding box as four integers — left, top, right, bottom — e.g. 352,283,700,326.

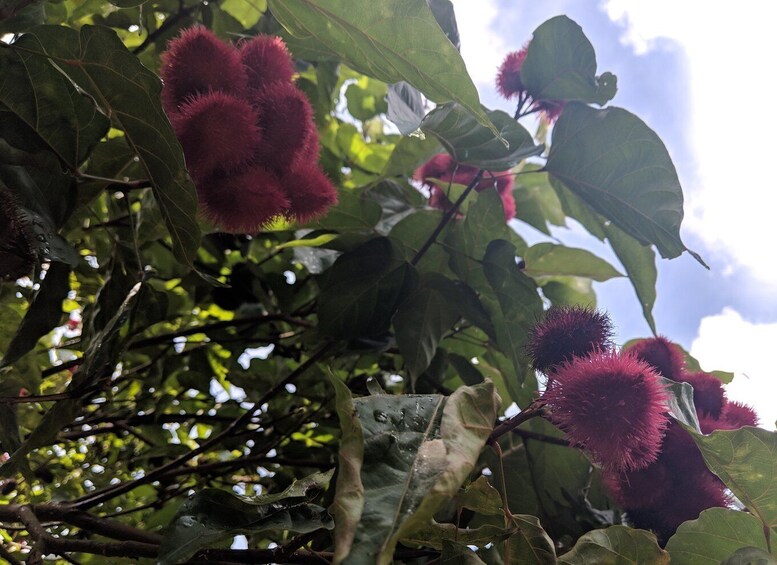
446,0,509,86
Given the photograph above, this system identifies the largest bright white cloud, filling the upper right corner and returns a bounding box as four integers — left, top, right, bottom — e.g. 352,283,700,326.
604,0,777,283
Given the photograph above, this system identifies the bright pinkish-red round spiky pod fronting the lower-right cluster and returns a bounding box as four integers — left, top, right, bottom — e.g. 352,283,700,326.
543,351,669,471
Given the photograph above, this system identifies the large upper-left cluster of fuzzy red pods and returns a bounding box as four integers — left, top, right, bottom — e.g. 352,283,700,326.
161,27,337,233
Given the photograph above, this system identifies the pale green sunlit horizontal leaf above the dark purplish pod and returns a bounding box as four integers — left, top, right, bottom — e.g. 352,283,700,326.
523,243,623,282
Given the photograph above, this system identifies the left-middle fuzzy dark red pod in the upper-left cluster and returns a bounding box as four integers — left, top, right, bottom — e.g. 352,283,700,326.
171,92,261,180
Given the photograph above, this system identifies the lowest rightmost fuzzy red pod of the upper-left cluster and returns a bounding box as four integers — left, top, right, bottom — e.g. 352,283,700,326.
283,163,337,224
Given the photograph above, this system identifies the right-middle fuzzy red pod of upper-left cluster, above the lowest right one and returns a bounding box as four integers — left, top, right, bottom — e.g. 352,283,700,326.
256,82,318,171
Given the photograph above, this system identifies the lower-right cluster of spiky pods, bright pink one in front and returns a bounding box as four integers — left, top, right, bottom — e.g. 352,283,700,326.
528,307,758,543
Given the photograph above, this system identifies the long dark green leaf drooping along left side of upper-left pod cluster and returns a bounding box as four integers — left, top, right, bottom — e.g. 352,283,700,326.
27,25,200,264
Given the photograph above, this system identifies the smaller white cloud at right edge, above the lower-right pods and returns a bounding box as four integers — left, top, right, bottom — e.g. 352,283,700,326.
691,307,777,429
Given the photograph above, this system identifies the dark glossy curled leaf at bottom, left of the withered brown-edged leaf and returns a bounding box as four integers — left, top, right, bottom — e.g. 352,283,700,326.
159,471,333,565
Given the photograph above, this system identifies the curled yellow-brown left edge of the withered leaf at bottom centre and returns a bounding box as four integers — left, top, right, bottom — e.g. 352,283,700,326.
329,375,364,563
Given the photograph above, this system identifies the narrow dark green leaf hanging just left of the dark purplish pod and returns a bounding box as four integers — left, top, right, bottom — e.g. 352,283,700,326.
483,240,542,406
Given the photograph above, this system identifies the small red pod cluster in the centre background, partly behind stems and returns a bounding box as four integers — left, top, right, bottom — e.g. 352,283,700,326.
413,153,515,221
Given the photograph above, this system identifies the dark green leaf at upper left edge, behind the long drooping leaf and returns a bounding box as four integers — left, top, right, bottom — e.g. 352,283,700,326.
0,35,110,170
